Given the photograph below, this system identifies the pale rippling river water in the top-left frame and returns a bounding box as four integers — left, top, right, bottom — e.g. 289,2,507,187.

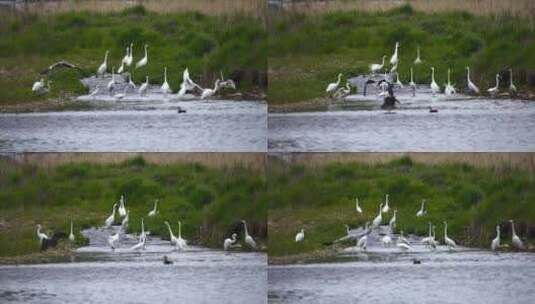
0,100,267,152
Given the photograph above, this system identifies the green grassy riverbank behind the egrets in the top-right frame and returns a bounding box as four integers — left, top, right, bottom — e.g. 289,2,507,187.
268,5,535,104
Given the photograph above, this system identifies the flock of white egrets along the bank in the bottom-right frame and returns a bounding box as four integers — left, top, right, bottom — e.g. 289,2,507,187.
295,194,525,252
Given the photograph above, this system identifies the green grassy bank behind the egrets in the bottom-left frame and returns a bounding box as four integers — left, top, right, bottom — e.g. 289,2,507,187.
0,158,267,257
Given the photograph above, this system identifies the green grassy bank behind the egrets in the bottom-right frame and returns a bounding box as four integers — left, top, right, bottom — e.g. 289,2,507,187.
268,158,535,256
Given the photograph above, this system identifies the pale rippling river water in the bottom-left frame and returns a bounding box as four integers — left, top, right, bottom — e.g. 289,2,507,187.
0,230,267,303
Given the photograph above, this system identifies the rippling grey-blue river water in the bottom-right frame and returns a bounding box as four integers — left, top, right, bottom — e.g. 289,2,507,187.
268,250,535,304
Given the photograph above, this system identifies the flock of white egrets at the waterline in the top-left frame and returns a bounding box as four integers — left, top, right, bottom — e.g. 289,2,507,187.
32,43,236,100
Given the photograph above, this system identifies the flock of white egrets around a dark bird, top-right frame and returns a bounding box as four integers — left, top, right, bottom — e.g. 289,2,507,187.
325,42,518,99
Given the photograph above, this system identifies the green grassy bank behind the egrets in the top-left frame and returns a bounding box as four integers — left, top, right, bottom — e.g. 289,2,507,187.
0,6,267,104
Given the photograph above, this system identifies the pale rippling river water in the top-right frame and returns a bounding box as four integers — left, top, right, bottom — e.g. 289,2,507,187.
268,93,535,152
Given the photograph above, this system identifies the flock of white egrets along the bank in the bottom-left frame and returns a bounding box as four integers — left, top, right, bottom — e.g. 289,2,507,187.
36,195,257,251
